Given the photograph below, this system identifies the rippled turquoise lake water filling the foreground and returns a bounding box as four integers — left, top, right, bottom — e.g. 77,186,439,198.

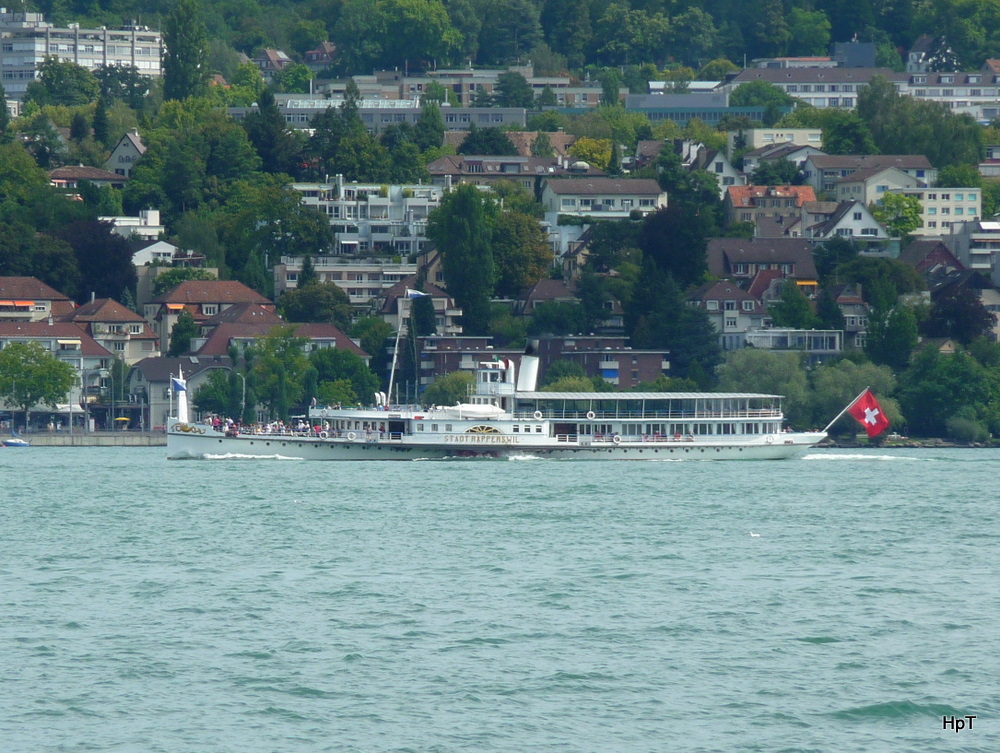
0,448,1000,753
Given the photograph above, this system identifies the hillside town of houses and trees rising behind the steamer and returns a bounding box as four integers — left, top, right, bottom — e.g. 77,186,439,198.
0,0,1000,442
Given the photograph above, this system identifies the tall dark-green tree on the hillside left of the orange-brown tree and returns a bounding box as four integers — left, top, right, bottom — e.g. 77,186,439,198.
427,185,498,335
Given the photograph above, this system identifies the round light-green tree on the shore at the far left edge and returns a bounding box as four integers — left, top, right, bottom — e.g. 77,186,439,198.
0,341,76,426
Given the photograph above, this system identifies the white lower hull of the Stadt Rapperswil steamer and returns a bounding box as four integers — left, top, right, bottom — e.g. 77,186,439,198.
167,421,826,460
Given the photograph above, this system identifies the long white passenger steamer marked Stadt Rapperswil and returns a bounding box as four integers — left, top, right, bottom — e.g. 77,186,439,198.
167,346,826,460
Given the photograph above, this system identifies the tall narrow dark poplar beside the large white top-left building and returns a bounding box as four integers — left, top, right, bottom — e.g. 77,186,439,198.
163,0,209,100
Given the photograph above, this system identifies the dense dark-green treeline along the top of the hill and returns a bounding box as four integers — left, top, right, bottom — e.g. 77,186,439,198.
19,0,1000,74
